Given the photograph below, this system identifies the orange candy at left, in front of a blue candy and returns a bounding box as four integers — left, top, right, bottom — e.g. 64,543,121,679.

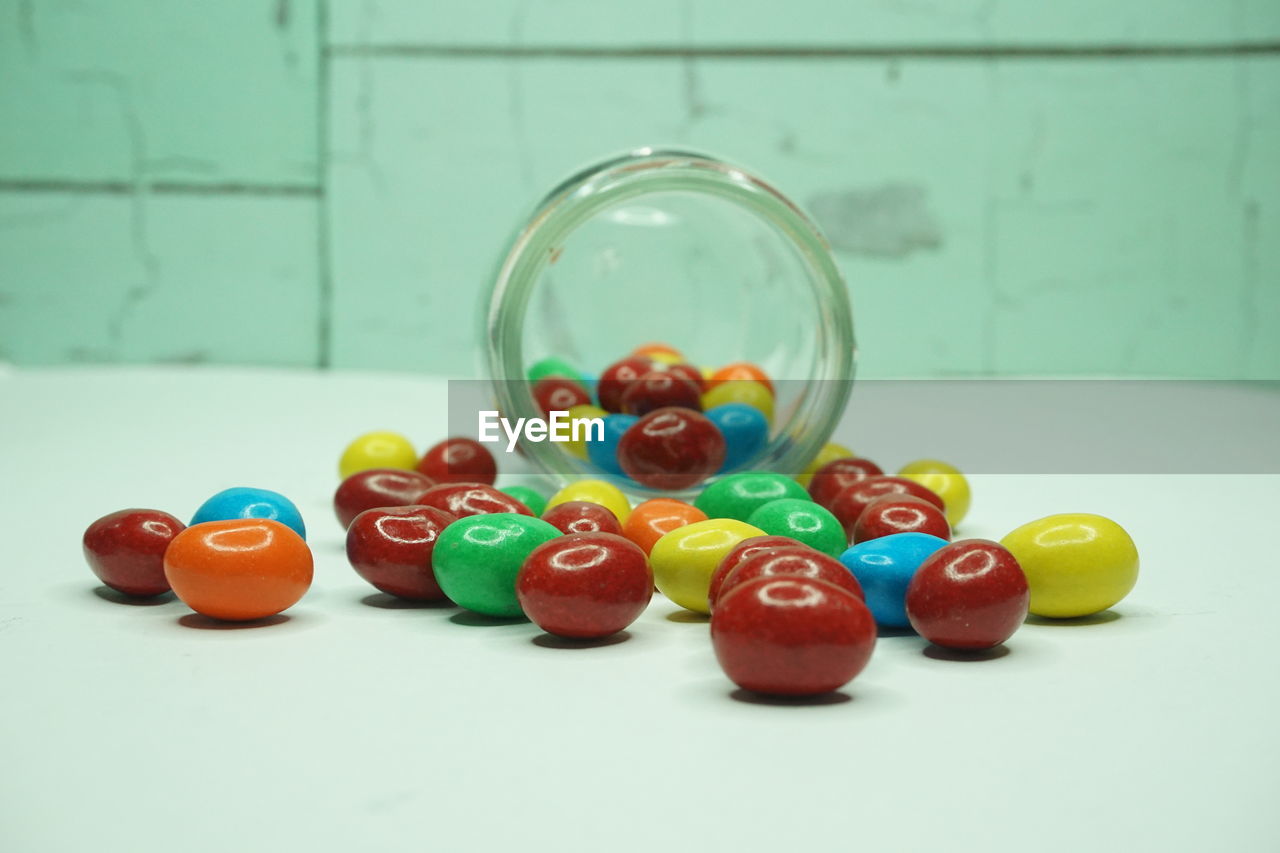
164,519,312,621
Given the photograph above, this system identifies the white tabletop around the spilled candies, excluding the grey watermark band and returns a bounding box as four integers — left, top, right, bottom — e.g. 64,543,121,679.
0,368,1280,853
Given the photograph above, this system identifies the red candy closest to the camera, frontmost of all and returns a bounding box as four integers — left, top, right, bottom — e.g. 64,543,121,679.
712,578,876,695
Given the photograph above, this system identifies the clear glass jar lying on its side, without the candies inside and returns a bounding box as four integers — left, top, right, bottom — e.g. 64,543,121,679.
486,149,855,497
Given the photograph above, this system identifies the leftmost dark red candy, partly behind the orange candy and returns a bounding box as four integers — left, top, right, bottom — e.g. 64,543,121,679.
82,510,186,598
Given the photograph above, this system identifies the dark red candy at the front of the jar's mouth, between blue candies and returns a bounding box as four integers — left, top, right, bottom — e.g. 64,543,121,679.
618,407,724,489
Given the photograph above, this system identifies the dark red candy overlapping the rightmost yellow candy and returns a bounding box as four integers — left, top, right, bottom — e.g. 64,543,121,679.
906,539,1029,651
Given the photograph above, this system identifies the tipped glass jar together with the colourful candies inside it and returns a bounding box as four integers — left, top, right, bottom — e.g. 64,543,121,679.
486,149,854,497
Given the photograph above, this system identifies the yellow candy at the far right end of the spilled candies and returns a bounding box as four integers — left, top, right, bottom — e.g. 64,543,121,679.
1000,512,1138,619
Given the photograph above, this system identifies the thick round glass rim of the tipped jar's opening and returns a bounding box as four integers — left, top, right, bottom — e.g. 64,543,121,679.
485,147,856,497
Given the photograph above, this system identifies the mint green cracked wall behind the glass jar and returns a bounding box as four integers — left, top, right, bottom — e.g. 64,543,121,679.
0,0,1280,378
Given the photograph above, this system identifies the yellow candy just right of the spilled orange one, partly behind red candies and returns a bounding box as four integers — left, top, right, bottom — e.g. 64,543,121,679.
649,519,764,613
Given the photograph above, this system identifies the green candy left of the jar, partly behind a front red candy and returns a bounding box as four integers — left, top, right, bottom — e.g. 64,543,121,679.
431,512,561,619
